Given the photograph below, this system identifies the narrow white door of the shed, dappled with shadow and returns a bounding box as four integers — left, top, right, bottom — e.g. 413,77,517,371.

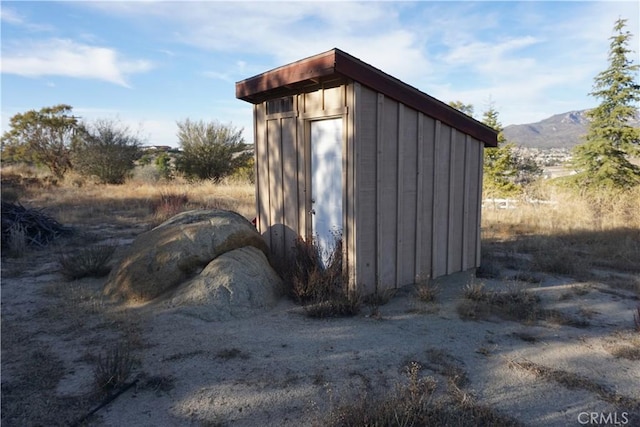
311,118,342,263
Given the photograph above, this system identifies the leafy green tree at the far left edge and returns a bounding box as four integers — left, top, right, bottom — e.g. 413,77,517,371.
2,104,79,178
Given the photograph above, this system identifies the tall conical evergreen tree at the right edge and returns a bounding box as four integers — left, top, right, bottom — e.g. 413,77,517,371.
572,19,640,189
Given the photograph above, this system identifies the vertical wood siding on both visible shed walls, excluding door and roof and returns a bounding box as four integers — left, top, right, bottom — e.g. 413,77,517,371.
254,82,483,293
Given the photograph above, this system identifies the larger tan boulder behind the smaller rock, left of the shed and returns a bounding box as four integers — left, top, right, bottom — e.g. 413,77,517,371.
104,210,270,302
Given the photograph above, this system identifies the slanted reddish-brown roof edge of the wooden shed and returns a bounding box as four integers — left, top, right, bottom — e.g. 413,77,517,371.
236,48,498,147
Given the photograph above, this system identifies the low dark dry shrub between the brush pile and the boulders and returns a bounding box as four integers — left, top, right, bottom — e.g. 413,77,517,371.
58,245,116,280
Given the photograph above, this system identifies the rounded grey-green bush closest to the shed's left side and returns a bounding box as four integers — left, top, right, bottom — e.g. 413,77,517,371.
176,119,252,182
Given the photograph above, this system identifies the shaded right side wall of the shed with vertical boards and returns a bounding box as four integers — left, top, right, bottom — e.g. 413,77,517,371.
354,83,482,292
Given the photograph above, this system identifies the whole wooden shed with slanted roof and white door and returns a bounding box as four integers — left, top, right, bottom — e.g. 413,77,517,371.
236,49,497,293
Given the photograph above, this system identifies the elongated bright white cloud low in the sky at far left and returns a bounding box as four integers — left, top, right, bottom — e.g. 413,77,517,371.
0,39,153,87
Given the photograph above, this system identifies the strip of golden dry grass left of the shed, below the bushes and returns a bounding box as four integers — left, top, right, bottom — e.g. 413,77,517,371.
1,166,255,225
